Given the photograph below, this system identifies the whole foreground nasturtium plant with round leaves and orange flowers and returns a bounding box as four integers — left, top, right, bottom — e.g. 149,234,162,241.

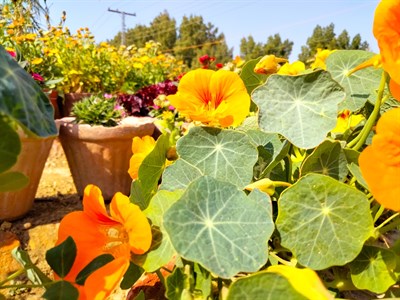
0,0,400,300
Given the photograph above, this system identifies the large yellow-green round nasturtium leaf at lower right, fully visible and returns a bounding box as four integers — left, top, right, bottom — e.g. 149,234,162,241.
276,174,374,270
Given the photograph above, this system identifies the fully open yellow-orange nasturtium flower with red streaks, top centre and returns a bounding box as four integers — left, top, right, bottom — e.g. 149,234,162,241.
167,69,250,127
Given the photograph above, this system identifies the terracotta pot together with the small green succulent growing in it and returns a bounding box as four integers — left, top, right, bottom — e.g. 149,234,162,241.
57,94,155,199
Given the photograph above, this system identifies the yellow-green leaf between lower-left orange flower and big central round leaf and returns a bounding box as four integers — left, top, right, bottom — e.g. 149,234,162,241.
132,190,183,272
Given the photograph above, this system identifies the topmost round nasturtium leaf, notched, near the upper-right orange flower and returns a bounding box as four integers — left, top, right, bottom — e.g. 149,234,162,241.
326,50,382,111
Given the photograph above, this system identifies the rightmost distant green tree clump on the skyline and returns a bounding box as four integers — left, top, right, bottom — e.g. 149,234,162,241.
299,23,369,62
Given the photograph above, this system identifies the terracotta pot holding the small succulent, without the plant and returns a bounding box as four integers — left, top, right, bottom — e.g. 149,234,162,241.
57,117,155,200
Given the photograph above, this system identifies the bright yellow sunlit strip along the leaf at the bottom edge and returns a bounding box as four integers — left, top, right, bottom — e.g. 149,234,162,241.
267,265,334,300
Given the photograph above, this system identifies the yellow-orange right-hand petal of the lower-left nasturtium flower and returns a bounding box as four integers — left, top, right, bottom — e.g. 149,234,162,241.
110,193,152,254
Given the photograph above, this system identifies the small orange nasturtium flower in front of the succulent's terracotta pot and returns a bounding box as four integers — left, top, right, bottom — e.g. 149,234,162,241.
128,135,156,180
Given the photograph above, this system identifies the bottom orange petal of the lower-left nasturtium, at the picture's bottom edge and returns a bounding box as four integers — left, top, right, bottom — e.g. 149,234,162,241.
84,258,129,300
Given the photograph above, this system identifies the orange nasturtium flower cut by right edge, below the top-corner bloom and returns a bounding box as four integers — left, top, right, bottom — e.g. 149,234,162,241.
359,108,400,211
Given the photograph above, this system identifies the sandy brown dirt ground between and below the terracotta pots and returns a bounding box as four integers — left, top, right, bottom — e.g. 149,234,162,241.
0,139,126,300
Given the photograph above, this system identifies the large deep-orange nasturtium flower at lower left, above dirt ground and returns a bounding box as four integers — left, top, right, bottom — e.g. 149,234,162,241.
57,185,152,299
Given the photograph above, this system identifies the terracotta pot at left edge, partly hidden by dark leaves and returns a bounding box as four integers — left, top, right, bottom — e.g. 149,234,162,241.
0,134,55,220
